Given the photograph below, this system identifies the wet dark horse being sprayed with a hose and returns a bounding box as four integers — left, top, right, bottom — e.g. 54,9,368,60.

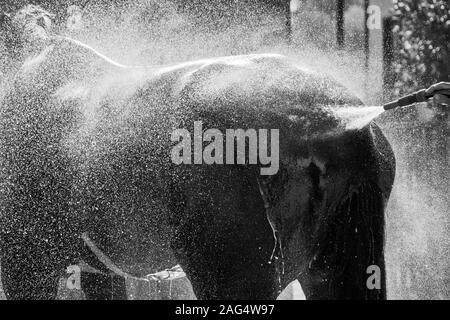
0,7,395,299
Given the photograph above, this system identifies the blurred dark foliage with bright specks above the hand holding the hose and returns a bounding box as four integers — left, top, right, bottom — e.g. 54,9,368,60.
393,0,450,95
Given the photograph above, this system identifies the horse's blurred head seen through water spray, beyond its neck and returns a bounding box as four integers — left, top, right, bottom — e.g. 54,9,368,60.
0,5,54,69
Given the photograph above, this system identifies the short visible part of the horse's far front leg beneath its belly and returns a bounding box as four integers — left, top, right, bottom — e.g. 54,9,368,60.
81,272,127,300
